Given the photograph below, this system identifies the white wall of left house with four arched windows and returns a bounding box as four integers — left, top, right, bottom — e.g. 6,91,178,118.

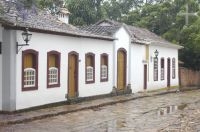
16,31,113,109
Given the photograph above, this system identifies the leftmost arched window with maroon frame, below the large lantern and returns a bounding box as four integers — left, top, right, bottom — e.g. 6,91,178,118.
22,49,38,91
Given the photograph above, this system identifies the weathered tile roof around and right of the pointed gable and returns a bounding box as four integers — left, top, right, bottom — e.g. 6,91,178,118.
81,19,181,48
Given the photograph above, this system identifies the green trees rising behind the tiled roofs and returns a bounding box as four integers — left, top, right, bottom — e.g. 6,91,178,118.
21,0,200,69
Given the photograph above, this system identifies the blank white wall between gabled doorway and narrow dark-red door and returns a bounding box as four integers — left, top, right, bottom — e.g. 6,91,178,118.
131,44,146,93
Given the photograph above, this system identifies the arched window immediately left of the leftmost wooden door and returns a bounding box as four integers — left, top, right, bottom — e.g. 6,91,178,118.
47,51,60,88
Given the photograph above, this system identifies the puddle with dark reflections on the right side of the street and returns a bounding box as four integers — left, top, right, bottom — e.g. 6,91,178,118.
158,104,187,116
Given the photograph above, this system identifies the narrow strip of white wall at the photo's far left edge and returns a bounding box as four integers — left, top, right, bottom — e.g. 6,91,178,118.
0,25,3,110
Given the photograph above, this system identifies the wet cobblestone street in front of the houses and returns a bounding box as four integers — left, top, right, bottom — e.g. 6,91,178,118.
0,90,200,132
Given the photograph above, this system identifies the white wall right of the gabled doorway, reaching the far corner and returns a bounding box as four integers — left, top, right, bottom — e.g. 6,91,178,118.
131,44,179,92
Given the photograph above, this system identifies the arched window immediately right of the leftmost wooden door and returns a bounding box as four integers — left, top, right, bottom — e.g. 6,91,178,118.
85,53,95,83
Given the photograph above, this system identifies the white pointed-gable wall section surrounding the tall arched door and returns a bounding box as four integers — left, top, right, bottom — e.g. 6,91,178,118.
113,27,130,87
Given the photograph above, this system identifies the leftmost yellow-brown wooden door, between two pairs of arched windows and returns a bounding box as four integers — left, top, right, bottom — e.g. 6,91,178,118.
68,52,78,98
